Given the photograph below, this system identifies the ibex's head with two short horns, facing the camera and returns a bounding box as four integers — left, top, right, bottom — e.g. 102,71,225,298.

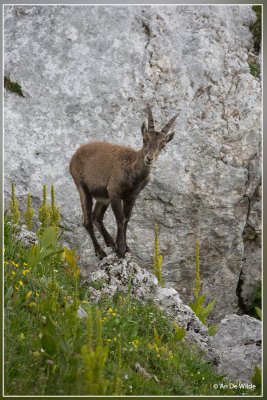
141,104,179,166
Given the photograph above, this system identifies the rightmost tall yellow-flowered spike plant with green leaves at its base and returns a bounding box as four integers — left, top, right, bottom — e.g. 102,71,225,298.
189,241,219,336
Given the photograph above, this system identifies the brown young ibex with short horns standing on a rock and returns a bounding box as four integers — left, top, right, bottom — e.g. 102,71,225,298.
70,105,178,260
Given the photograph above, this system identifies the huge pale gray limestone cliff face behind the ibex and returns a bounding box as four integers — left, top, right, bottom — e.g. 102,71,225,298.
4,5,261,320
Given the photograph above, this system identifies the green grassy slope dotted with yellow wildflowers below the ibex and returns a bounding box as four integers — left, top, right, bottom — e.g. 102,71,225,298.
4,217,259,396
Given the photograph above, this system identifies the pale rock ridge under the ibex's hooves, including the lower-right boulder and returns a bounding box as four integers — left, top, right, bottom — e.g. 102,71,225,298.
82,254,262,383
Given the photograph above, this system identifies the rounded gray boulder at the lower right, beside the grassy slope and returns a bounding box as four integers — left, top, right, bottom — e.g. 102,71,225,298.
213,314,262,383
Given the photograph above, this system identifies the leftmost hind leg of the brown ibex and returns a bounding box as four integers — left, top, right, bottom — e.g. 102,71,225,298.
78,185,107,260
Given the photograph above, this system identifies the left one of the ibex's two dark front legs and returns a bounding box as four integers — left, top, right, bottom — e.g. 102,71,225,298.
109,194,126,257
